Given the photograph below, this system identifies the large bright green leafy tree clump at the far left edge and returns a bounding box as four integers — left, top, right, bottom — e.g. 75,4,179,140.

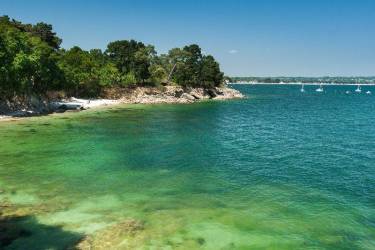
0,17,62,98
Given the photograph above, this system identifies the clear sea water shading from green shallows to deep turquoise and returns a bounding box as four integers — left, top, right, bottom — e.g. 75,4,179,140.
0,85,375,249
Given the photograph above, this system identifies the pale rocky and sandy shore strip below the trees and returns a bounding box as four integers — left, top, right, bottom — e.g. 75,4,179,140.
0,86,244,121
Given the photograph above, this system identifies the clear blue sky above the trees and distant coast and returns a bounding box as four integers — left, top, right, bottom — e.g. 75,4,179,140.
0,0,375,76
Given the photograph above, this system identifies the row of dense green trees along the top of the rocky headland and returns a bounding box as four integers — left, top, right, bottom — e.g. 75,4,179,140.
0,16,224,99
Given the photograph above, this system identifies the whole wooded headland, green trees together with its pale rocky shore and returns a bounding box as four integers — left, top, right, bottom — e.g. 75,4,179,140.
0,16,244,120
